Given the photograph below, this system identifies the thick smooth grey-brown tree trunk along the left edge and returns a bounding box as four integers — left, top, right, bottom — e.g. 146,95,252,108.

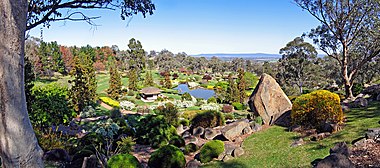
0,0,43,168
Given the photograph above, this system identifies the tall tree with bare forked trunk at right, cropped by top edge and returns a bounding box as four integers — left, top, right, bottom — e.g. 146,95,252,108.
295,0,380,98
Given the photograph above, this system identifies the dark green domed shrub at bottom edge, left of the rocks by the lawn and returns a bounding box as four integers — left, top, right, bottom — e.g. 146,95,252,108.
148,145,186,168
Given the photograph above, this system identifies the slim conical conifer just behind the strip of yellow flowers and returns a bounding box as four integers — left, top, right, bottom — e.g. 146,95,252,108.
107,65,122,100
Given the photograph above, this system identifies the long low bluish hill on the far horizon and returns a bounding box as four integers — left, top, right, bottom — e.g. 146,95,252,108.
192,53,281,61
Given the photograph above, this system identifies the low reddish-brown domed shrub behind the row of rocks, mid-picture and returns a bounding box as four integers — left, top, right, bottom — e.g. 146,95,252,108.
191,111,225,128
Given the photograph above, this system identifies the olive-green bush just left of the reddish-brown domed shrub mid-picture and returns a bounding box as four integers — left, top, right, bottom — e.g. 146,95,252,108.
155,103,179,127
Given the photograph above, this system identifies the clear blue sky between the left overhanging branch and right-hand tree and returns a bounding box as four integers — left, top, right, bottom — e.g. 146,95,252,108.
29,0,319,54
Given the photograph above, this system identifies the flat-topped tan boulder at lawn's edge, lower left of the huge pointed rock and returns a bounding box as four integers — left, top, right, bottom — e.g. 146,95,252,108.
221,119,250,141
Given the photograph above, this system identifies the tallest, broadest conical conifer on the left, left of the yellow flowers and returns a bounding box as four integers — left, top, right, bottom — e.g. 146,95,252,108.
70,52,96,112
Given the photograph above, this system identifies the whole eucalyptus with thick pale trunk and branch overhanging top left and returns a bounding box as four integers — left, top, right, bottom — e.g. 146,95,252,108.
0,0,155,168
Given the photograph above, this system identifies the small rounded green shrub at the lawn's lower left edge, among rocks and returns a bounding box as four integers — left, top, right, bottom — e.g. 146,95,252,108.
199,140,224,163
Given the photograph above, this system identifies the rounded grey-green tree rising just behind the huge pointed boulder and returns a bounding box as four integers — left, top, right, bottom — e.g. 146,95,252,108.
279,37,318,94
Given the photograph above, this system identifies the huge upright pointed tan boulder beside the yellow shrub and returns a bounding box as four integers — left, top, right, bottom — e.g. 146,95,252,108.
248,74,292,125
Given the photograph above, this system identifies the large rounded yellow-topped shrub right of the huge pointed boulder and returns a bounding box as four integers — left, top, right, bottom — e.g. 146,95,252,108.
291,90,343,129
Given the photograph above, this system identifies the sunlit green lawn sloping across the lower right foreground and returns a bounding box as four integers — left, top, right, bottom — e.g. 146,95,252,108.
204,102,380,168
